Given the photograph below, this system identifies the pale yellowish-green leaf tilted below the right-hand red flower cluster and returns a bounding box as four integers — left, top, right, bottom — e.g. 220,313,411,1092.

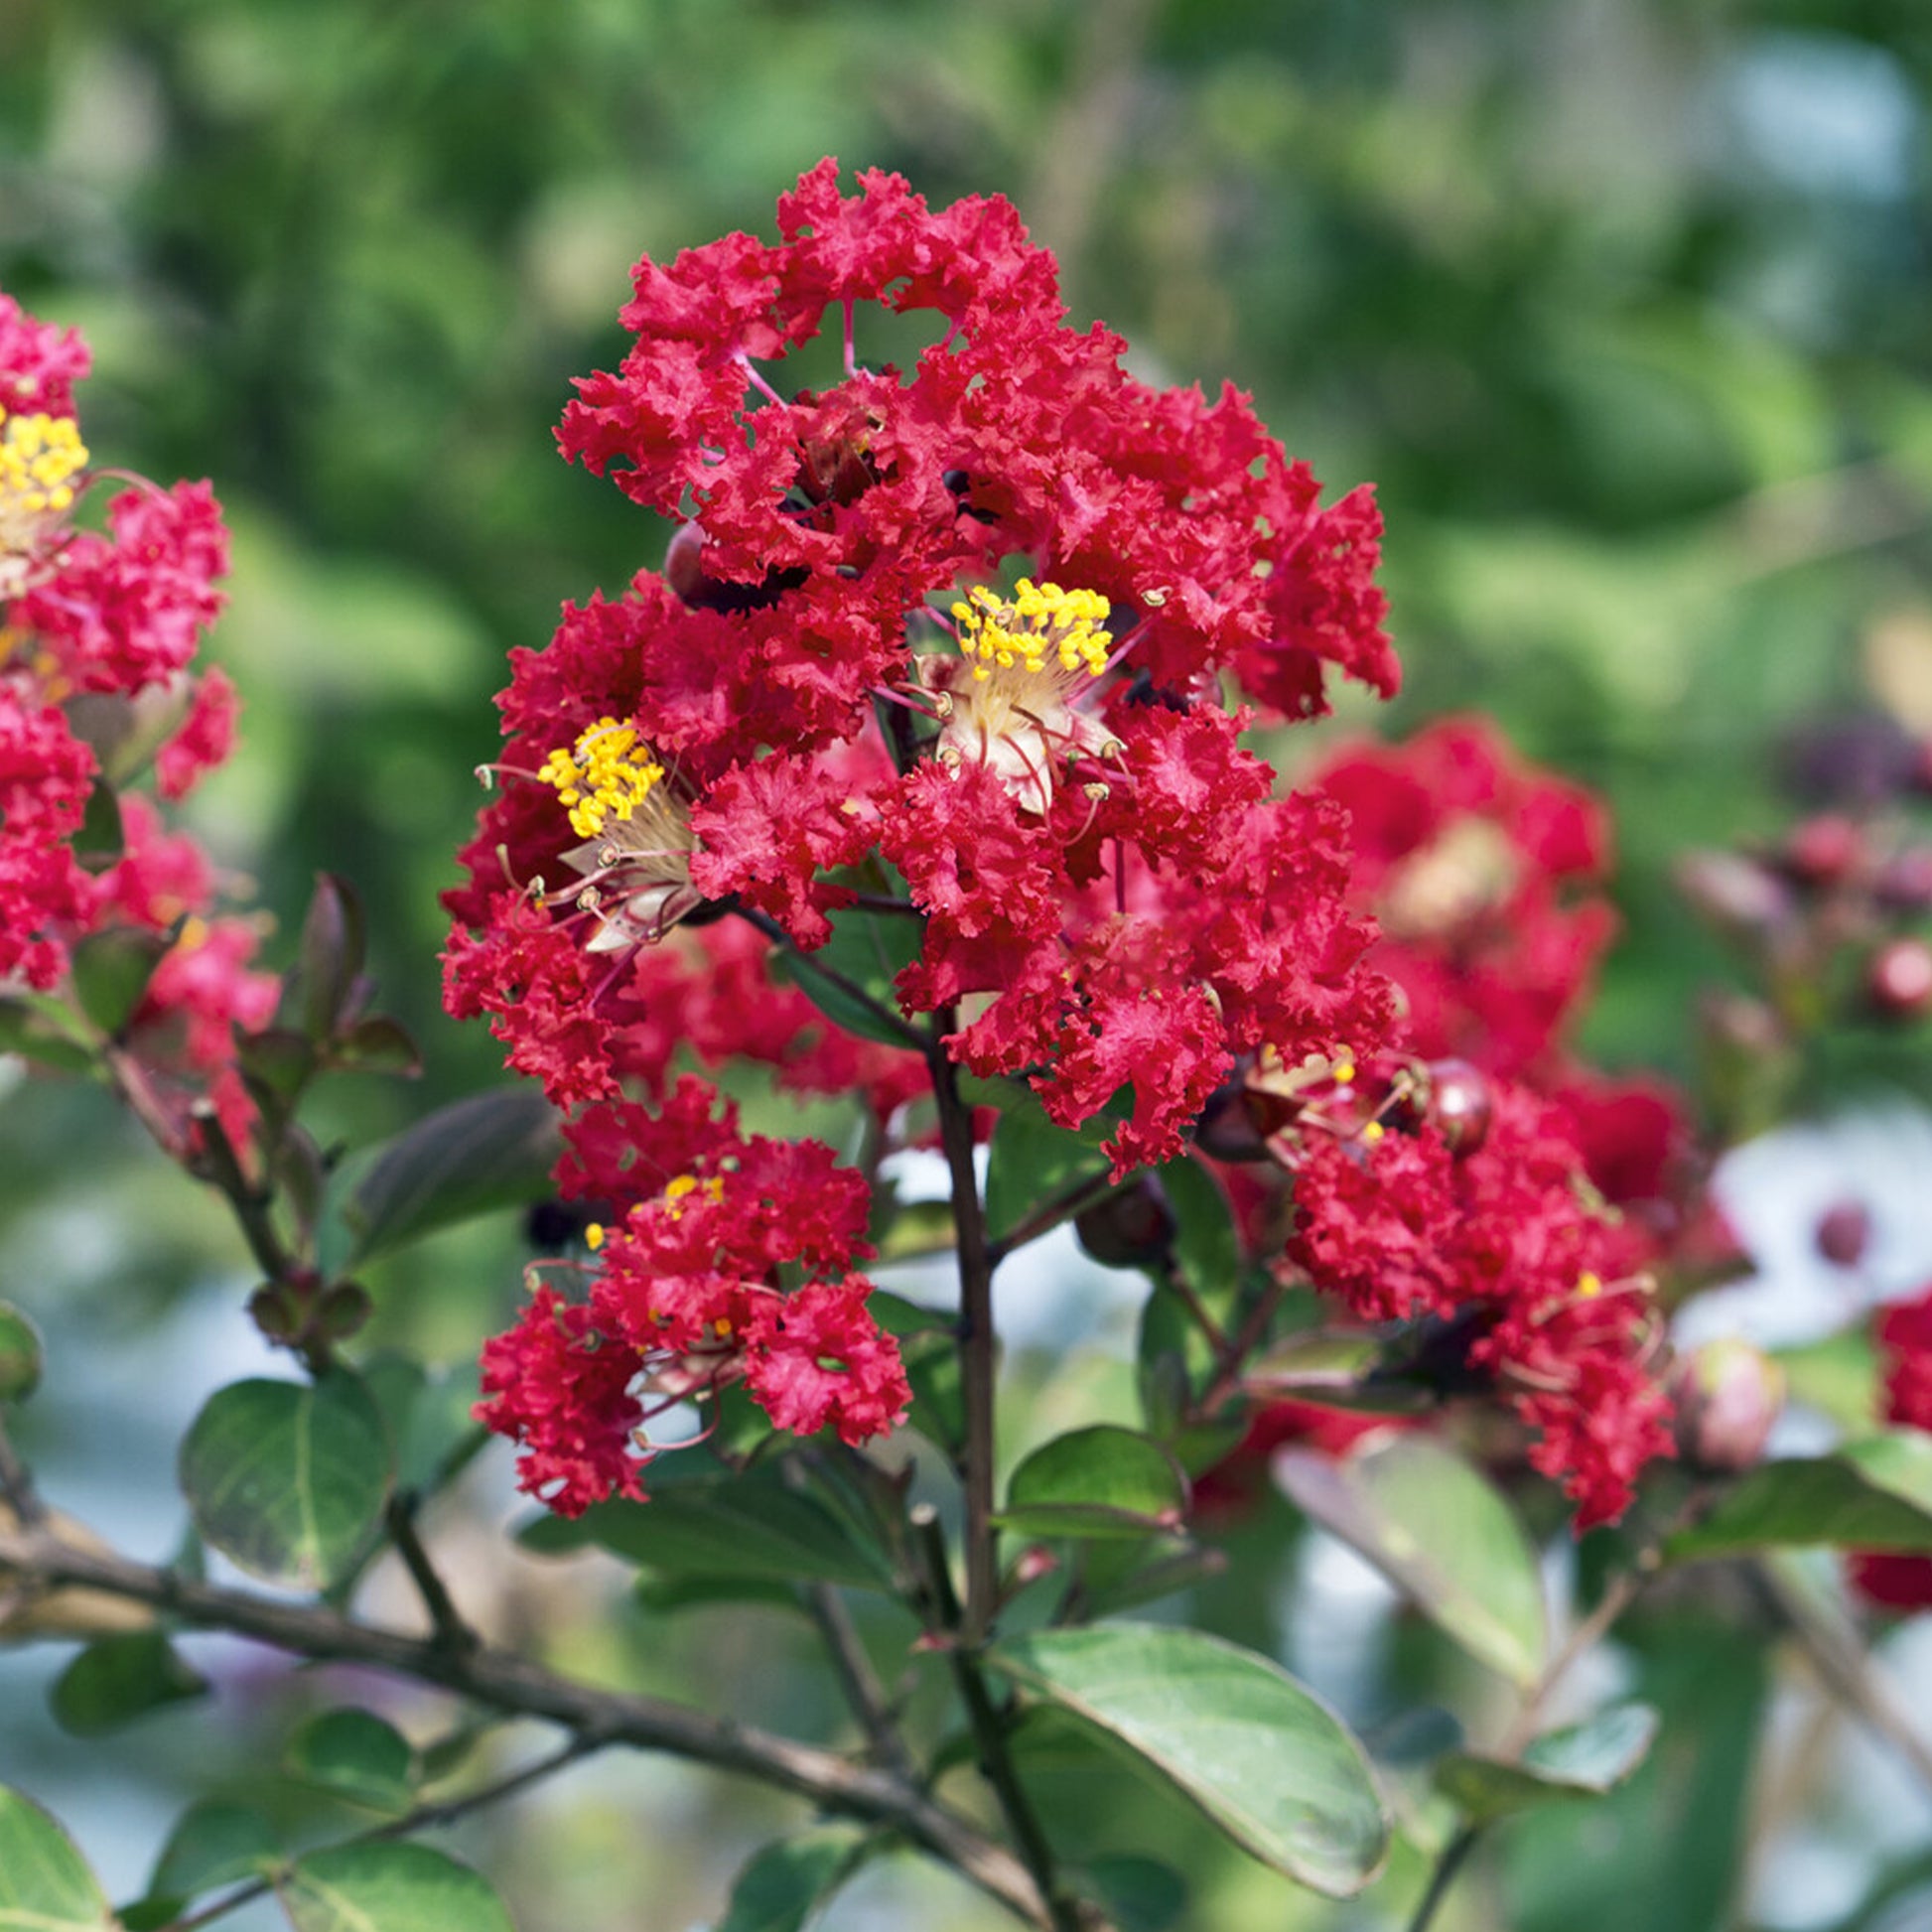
1273,1436,1548,1685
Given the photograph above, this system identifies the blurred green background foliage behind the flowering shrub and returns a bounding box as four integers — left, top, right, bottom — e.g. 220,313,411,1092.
0,0,1932,1932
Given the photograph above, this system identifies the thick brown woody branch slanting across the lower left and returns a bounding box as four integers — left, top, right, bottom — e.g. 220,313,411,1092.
0,1528,1055,1932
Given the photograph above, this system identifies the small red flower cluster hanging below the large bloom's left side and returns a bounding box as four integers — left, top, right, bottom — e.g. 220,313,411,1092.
478,1076,912,1517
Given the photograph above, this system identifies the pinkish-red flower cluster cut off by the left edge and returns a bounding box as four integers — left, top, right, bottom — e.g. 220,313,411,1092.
0,296,276,1132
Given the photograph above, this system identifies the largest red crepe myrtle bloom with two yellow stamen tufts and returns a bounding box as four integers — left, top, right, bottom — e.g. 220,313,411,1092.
448,162,1395,1171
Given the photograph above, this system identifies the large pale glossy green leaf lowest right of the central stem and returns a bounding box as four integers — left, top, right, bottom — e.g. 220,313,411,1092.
987,1623,1389,1897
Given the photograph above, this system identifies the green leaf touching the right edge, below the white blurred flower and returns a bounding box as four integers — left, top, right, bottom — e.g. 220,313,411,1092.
1664,1430,1932,1563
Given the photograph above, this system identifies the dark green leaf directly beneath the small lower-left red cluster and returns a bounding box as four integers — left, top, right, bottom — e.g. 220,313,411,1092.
521,1470,893,1590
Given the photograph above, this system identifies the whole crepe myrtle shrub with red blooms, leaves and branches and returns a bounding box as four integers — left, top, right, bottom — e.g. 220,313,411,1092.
0,161,1932,1932
